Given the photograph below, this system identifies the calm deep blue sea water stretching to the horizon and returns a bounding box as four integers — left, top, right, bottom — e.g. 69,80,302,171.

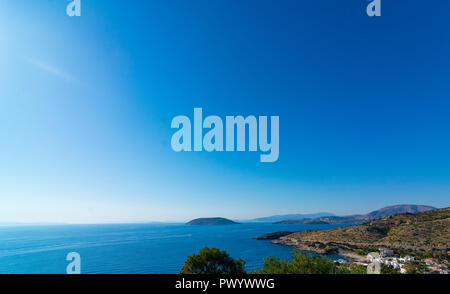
0,223,342,274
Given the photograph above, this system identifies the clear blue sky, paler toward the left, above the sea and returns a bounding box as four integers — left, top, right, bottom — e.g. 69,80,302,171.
0,0,450,223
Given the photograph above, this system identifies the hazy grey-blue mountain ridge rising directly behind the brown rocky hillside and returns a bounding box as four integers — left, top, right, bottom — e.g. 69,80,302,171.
275,204,436,224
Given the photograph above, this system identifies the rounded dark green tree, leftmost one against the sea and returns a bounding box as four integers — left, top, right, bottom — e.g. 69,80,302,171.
180,247,245,274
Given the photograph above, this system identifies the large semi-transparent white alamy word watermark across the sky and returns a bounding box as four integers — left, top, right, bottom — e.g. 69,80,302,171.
171,108,280,162
